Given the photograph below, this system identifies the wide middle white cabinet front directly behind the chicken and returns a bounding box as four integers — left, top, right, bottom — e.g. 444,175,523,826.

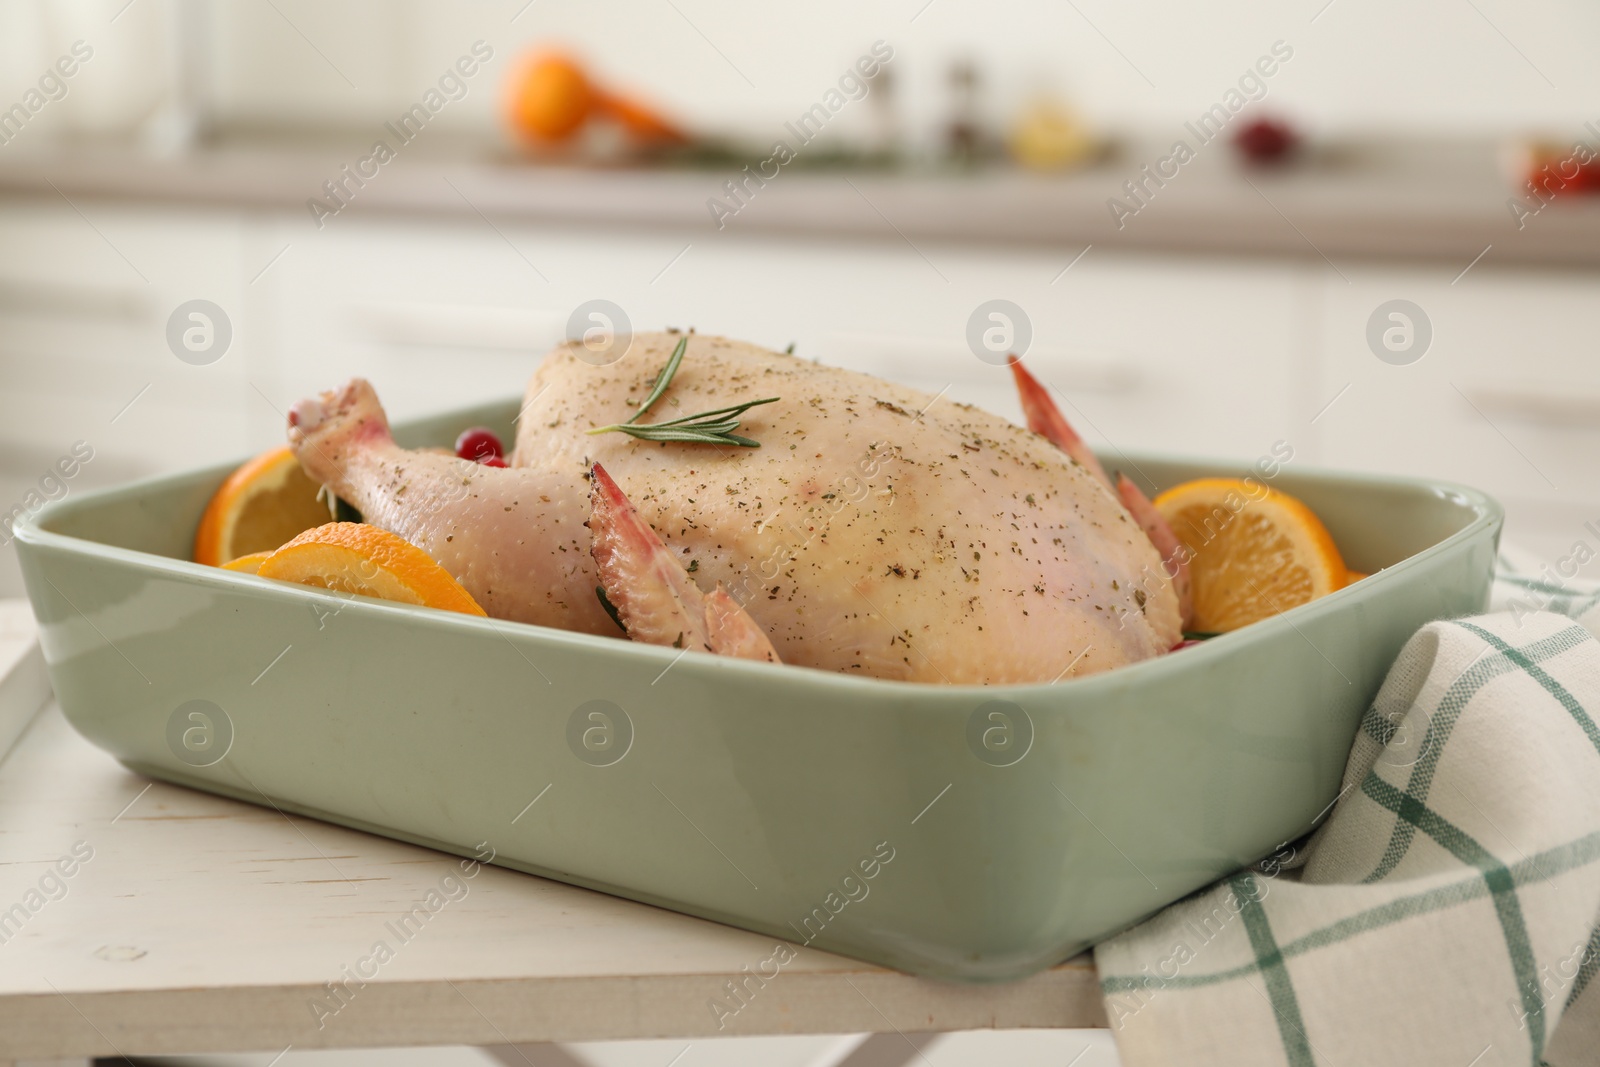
262,219,1315,470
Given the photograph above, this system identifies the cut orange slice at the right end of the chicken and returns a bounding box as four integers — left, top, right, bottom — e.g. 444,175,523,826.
1155,478,1349,633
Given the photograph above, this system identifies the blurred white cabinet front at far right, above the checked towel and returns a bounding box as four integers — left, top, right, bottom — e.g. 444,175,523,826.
1317,264,1600,518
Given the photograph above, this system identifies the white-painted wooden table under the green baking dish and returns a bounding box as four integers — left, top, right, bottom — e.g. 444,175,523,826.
0,639,1106,1064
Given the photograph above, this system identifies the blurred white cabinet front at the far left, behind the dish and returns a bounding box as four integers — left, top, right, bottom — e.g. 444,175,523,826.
0,202,264,480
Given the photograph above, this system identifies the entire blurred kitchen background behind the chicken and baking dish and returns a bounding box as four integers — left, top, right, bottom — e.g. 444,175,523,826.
0,0,1600,595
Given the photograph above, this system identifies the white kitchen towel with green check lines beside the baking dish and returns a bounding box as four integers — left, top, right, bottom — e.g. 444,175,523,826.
1094,555,1600,1067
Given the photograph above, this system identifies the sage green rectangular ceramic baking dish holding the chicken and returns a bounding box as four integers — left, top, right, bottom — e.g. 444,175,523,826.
18,403,1501,979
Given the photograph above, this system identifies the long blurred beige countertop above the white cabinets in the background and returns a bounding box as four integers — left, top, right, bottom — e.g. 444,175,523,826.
0,131,1600,269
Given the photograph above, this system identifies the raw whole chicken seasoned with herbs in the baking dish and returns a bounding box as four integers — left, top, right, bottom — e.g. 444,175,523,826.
290,333,1186,685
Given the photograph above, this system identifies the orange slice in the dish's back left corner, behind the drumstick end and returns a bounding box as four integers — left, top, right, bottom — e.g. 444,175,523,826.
195,448,330,566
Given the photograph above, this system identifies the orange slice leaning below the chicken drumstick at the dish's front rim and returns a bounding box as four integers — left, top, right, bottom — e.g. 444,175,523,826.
256,523,486,614
